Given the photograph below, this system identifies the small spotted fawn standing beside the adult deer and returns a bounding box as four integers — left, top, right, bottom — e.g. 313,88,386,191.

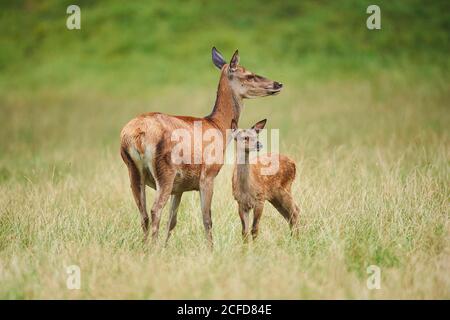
232,119,299,241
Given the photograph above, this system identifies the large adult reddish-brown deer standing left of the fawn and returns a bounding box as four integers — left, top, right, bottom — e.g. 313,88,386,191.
120,48,282,246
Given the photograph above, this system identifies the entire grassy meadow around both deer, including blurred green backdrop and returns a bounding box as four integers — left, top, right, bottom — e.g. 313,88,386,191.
0,0,450,299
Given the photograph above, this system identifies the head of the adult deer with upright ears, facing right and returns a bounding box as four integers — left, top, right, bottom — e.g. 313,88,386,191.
212,47,283,98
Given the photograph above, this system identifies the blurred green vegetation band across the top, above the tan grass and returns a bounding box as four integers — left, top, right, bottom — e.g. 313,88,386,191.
0,0,450,94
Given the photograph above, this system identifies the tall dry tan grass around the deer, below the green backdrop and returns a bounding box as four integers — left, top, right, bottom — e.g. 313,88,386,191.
0,75,450,299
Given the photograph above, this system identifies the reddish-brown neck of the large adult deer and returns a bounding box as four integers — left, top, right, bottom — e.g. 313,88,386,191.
208,68,243,132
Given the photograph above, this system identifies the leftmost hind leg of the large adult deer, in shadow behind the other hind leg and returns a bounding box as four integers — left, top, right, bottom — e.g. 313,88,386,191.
121,150,149,242
